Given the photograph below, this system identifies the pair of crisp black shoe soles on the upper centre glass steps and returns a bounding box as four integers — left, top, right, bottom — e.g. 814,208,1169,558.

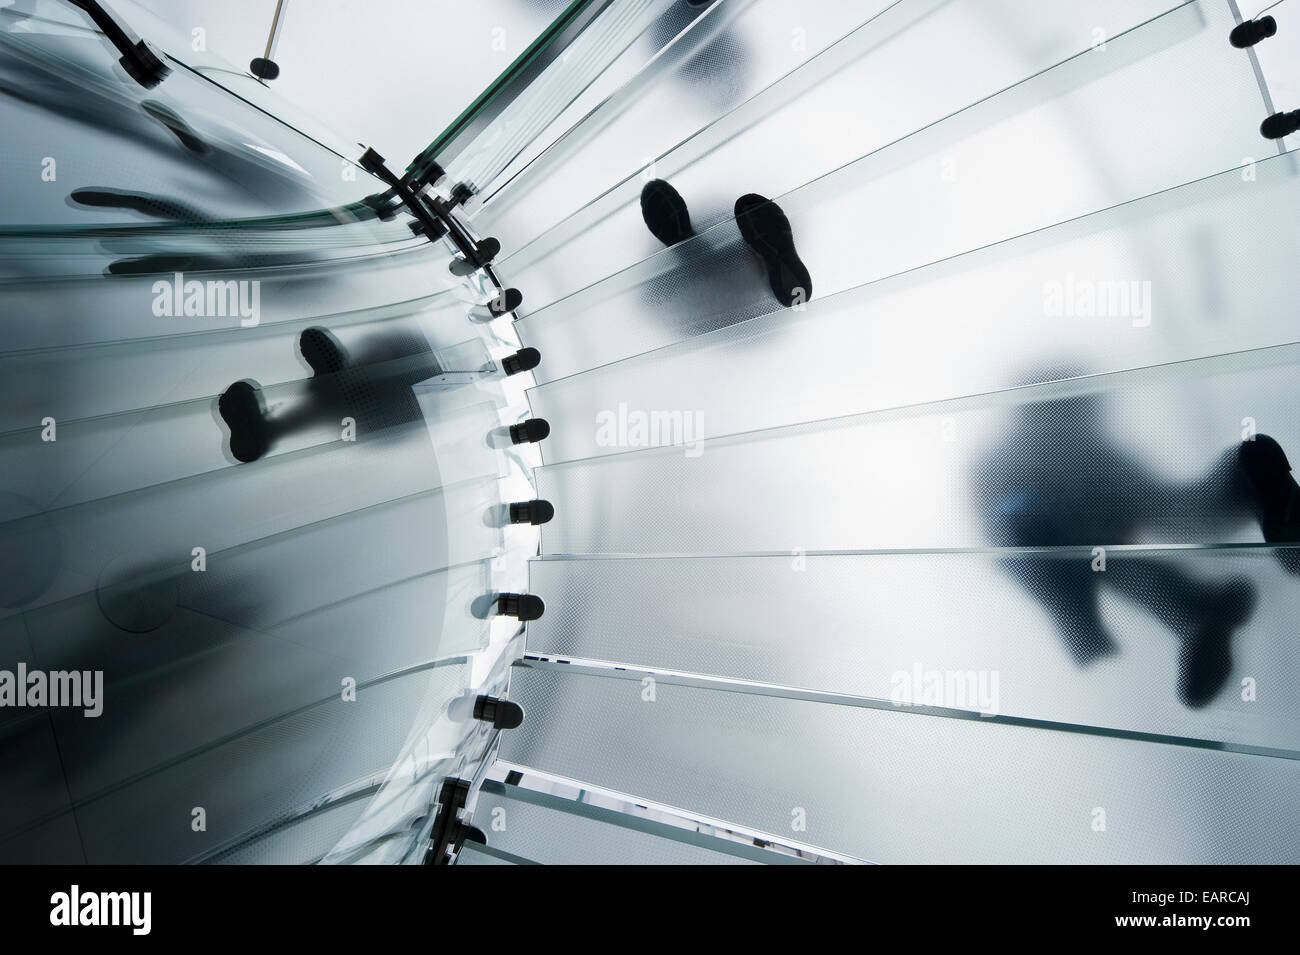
641,179,813,308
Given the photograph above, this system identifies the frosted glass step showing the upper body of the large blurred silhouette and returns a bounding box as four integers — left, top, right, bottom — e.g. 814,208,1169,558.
538,346,1300,554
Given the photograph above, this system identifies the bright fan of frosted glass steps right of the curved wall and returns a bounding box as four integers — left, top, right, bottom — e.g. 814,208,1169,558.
476,0,1300,863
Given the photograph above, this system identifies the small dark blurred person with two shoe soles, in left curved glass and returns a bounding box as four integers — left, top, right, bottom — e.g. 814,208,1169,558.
217,327,442,464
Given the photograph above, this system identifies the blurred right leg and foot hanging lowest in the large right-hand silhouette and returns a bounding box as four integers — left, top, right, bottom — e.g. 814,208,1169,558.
1104,557,1256,708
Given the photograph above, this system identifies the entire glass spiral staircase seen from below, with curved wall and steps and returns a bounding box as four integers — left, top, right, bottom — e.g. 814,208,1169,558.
0,0,1300,864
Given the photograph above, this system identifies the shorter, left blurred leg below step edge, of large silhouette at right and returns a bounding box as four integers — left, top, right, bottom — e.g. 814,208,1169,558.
1005,555,1118,667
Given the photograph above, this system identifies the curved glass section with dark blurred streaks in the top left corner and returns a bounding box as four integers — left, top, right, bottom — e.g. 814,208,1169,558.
0,2,360,225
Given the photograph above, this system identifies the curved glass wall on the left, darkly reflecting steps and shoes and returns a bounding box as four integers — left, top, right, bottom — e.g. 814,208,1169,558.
0,0,538,863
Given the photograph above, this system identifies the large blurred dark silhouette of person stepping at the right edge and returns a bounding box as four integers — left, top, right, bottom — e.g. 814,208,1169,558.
974,374,1300,708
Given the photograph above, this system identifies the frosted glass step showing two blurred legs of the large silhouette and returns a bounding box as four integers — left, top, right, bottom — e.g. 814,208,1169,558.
528,547,1300,759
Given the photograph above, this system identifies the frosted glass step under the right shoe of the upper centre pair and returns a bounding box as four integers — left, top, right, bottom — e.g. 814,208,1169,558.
519,3,1260,379
